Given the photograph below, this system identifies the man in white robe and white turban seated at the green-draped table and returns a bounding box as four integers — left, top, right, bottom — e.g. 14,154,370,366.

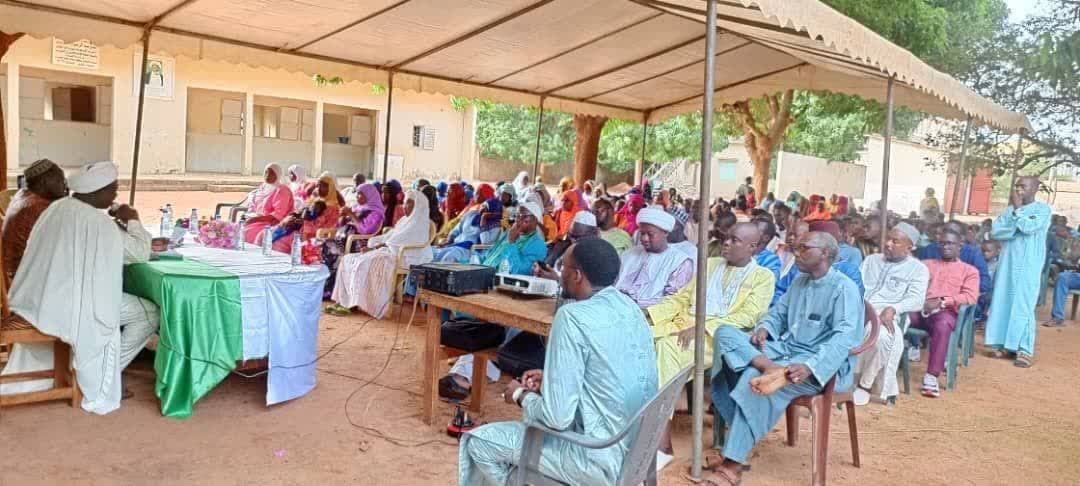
0,162,159,414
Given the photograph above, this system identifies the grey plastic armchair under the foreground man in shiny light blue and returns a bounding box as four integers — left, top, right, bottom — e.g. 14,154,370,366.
510,366,693,486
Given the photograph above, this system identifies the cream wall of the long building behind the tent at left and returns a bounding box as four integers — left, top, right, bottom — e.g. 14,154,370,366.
3,35,473,177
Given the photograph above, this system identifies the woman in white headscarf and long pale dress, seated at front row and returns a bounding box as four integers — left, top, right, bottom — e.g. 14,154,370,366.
326,190,432,319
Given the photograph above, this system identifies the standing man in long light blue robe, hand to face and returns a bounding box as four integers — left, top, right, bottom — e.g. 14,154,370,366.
985,176,1051,368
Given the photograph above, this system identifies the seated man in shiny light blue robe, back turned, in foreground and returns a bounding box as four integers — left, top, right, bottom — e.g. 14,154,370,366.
458,238,657,486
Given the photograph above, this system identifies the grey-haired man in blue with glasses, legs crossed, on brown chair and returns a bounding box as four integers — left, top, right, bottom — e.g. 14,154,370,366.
703,232,863,484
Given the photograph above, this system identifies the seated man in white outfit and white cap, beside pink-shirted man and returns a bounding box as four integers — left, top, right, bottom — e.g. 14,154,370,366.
853,222,930,405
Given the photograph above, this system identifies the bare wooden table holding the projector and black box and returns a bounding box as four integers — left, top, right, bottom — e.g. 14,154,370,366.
417,288,555,424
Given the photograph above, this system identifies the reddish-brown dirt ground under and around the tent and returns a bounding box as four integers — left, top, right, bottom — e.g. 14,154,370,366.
0,193,1080,486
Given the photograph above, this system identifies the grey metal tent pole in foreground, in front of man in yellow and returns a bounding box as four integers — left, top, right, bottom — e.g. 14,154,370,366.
691,0,716,480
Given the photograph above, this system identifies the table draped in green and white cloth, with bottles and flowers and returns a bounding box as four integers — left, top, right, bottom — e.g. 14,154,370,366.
124,237,329,418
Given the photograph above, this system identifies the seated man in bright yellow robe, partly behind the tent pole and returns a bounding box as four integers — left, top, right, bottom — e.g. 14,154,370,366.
648,222,775,469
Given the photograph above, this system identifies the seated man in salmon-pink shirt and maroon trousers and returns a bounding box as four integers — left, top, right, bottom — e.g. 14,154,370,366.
911,229,978,399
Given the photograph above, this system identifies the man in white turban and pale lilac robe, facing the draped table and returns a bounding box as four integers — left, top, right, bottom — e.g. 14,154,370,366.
616,206,693,309
